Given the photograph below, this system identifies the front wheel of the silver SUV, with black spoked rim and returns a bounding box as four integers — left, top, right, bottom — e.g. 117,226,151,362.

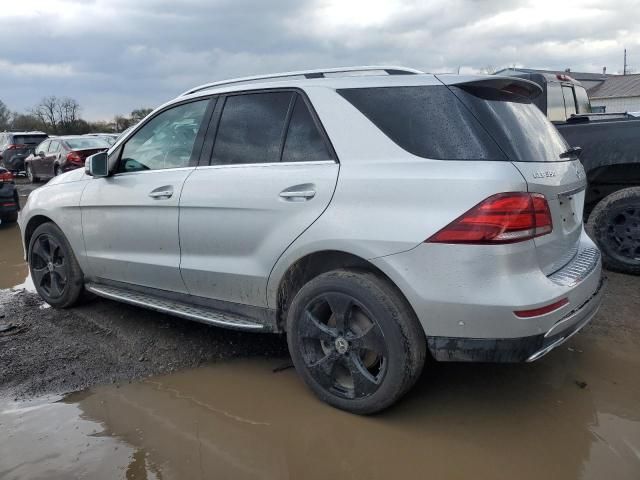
28,223,84,308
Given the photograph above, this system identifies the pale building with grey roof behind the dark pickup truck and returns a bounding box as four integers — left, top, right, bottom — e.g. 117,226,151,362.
587,74,640,113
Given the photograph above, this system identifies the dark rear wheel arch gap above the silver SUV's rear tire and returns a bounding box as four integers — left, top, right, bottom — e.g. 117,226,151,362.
275,250,415,331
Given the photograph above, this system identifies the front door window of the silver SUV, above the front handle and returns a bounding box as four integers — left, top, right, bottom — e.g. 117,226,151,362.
118,99,209,172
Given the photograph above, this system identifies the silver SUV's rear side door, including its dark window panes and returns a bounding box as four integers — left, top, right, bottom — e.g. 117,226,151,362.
180,90,339,306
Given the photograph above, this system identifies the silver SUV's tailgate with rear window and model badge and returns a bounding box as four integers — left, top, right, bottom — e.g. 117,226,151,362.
442,82,586,275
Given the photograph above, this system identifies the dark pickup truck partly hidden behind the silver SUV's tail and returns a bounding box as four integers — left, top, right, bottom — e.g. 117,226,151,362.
509,73,640,275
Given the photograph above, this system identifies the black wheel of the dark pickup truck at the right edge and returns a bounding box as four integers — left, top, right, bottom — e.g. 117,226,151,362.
587,187,640,275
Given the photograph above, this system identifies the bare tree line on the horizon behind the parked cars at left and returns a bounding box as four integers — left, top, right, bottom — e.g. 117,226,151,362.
0,95,152,135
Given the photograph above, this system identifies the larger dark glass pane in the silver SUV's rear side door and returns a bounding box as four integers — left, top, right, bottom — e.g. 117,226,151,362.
212,92,293,165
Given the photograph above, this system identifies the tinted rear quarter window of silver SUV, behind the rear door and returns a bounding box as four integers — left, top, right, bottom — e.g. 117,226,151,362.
338,85,505,160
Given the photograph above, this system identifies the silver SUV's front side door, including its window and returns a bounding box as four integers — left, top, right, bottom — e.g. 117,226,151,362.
81,99,211,293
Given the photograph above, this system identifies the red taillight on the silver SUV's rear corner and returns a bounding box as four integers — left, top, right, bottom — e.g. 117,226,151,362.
426,192,553,245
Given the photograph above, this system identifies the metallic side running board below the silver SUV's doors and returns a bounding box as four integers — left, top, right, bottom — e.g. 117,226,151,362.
85,283,265,331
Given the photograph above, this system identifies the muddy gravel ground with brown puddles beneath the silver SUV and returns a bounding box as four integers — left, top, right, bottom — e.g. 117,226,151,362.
0,178,640,480
